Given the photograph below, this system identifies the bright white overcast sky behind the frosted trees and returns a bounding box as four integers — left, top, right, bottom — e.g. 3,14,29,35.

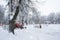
0,0,60,15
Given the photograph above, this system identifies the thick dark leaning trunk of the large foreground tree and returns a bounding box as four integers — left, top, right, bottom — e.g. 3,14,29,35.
9,0,21,34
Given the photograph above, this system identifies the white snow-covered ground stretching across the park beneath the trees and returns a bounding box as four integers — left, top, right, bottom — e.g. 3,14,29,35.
0,24,60,40
